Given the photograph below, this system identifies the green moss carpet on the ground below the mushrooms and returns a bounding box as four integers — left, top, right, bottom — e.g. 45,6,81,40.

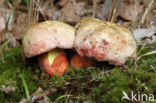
0,44,156,103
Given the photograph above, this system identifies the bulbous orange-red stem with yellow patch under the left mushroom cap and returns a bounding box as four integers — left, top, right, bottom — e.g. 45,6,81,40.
38,49,69,76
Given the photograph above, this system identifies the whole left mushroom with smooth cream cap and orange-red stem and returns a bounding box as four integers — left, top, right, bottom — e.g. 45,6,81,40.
23,21,75,76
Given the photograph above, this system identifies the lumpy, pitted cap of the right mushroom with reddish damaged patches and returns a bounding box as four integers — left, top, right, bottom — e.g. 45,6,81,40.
74,18,136,66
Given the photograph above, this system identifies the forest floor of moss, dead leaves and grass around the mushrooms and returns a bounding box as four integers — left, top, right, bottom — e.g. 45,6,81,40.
0,0,156,103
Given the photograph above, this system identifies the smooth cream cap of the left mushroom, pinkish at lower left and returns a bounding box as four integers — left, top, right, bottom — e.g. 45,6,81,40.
23,21,75,57
